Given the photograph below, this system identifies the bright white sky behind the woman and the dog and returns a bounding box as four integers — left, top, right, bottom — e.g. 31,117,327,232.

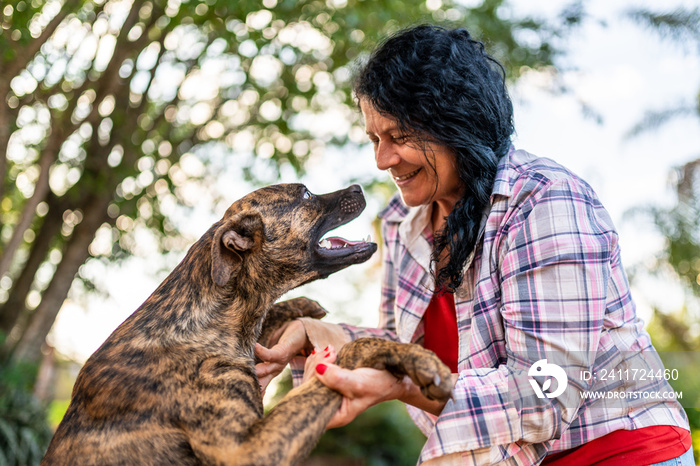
49,0,700,361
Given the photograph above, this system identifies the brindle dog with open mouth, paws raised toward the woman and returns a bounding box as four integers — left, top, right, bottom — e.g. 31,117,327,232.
43,184,450,466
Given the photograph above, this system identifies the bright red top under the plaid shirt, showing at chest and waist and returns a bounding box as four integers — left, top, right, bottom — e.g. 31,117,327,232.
423,292,692,466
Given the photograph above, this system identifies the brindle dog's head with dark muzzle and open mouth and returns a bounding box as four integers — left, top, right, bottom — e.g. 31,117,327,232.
211,184,377,290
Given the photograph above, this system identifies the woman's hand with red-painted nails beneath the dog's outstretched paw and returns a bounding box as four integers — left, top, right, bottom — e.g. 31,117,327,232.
304,346,457,429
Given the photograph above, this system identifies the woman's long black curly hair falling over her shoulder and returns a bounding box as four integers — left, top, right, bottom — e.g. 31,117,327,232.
354,25,513,291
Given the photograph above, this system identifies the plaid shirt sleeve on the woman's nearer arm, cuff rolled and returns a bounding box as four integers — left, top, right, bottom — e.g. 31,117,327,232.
410,180,617,464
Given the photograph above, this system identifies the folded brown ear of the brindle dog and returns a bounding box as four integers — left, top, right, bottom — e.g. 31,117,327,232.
211,212,263,286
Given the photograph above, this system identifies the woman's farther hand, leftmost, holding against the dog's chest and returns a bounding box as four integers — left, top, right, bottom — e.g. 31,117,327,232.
255,320,310,393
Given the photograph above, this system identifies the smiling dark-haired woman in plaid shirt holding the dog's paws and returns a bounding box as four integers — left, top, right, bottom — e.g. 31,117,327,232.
257,26,692,465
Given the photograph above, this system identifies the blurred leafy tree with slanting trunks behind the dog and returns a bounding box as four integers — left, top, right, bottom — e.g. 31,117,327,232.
0,0,571,370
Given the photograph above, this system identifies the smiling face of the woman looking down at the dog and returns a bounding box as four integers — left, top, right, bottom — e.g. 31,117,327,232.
360,100,463,216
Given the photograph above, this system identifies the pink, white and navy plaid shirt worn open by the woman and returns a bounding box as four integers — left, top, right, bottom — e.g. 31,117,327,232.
343,148,688,465
